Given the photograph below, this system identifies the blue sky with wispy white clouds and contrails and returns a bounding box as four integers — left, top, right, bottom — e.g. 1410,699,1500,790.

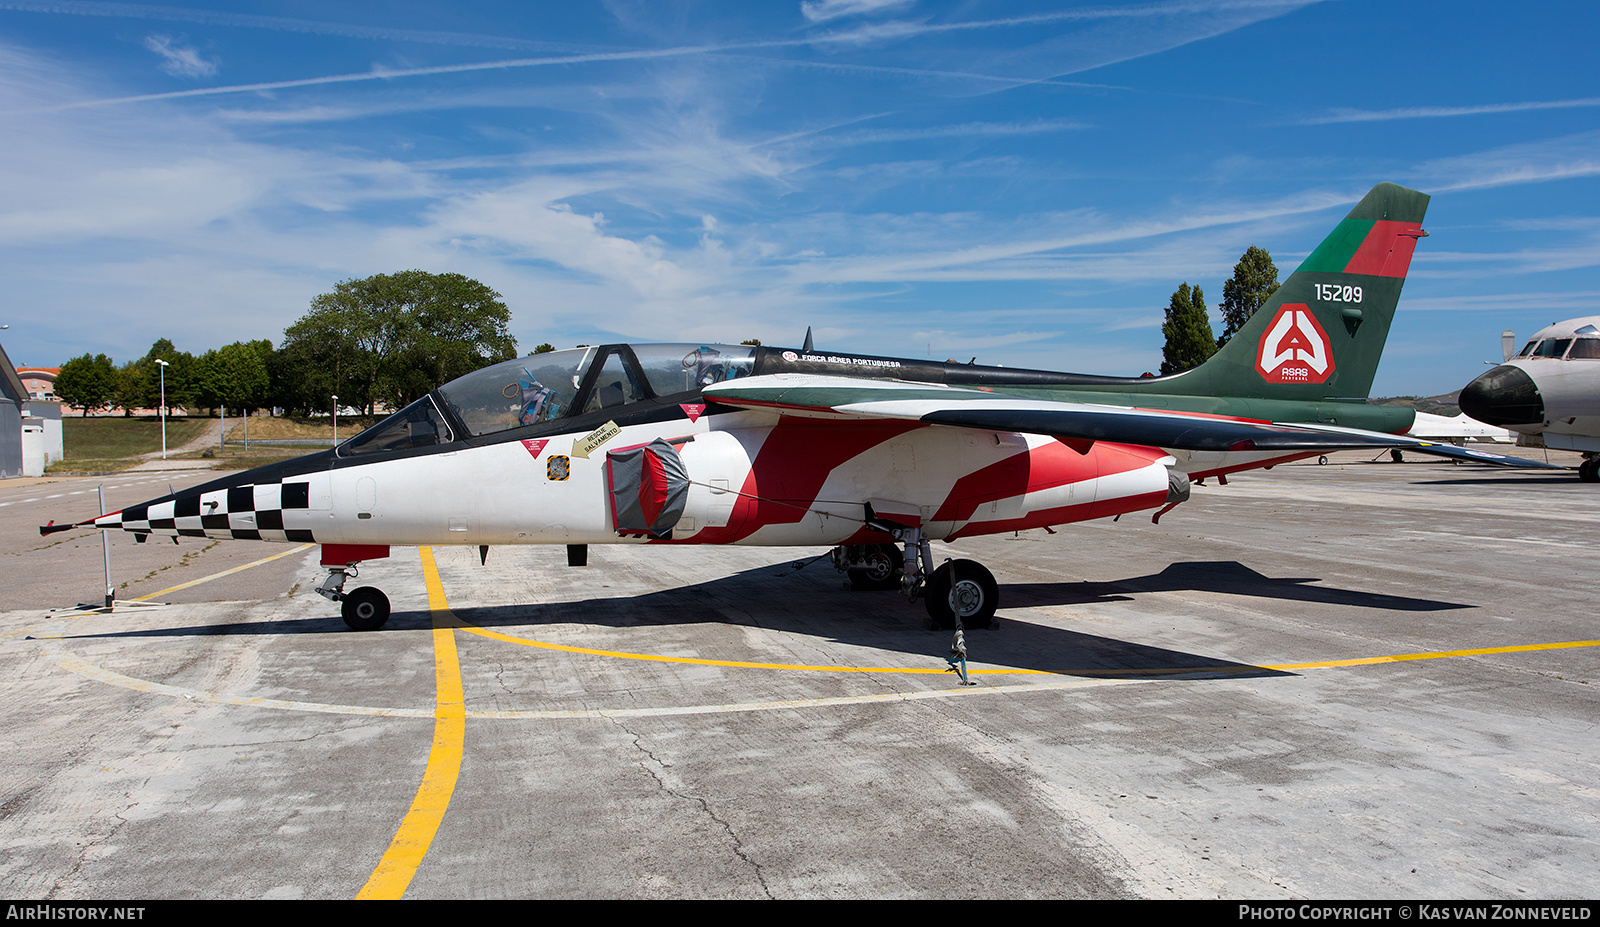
0,0,1600,395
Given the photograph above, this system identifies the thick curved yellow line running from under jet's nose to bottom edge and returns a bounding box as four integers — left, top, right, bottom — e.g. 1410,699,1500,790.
355,548,467,900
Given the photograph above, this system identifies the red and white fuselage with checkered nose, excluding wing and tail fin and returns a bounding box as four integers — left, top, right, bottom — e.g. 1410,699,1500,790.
84,344,1410,546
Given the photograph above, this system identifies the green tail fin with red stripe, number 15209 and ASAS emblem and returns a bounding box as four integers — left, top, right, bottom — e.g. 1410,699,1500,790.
1160,184,1429,402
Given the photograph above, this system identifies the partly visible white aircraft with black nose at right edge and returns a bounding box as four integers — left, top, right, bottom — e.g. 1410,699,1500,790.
1459,315,1600,484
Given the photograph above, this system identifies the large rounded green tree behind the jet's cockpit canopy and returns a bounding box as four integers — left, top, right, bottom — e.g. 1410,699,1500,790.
283,271,517,415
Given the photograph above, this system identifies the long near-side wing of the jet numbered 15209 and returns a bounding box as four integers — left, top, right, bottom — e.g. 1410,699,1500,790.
706,373,1562,469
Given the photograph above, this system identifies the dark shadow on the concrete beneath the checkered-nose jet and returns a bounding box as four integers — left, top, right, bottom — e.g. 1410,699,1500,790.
56,562,1440,679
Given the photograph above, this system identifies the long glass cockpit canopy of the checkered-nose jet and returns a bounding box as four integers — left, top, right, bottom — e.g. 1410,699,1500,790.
338,344,755,456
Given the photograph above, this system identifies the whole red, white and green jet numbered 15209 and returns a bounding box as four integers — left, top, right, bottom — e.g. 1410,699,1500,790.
42,184,1529,629
